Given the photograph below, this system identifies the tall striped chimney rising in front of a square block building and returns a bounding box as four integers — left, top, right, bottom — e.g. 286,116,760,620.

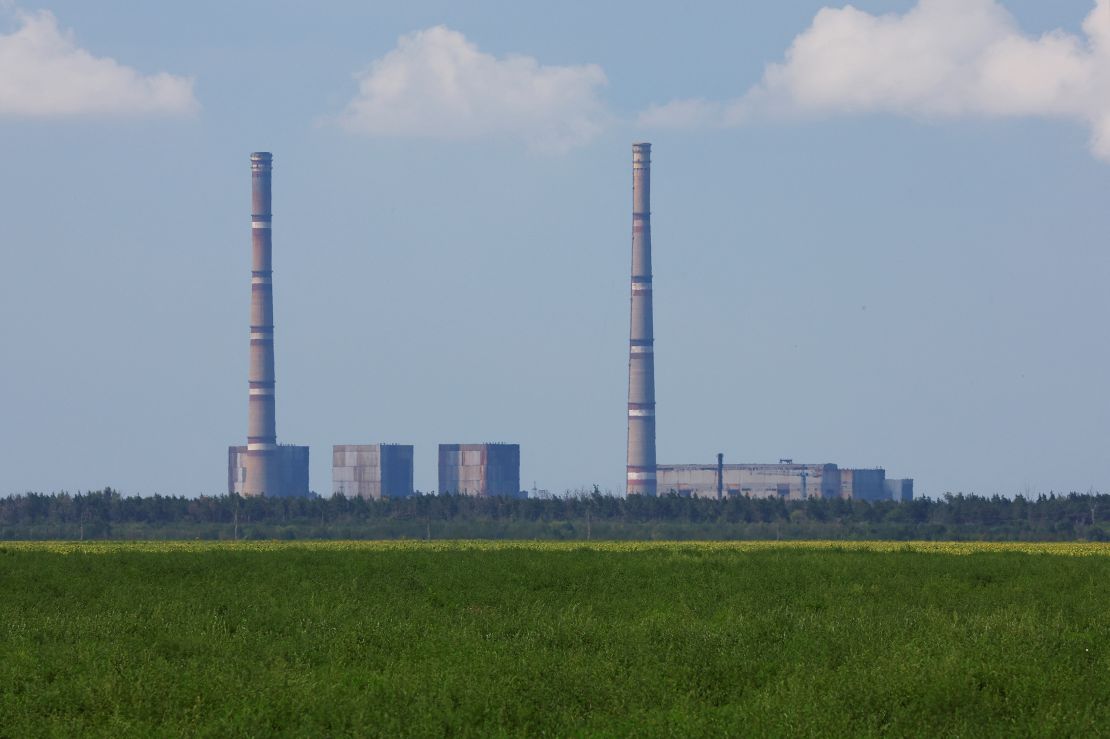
243,151,281,495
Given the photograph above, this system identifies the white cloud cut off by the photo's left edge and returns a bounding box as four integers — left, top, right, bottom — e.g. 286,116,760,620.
0,6,199,118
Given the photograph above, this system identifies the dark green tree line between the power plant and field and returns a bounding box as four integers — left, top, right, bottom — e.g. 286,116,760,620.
0,488,1110,541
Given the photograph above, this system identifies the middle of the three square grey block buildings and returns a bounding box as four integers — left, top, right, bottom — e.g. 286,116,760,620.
332,444,413,500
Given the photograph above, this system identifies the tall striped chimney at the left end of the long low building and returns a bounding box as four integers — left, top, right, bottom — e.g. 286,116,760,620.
627,143,656,496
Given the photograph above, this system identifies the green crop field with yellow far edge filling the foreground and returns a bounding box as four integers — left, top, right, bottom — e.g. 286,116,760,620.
0,541,1110,737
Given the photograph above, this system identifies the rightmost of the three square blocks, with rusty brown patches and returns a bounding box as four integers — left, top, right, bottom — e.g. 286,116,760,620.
440,444,521,498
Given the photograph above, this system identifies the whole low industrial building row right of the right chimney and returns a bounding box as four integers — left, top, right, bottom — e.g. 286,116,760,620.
657,455,914,500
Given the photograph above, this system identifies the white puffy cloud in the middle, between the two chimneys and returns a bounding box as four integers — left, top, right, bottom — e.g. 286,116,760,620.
339,26,609,151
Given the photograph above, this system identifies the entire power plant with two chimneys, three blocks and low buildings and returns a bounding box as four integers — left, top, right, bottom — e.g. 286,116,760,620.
228,142,914,500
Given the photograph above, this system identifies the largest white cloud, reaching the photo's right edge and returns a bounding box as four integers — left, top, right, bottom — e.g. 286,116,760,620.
640,0,1110,160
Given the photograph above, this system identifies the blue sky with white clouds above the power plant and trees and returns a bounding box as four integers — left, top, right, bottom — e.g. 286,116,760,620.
0,0,1110,497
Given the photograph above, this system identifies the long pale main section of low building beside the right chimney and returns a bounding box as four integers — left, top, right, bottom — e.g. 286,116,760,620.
656,463,840,500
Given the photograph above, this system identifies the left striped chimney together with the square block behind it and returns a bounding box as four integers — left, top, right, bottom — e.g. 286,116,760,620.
228,151,309,497
